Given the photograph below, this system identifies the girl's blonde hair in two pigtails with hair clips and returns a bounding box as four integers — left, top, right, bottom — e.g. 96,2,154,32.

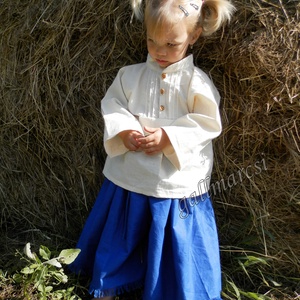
130,0,235,36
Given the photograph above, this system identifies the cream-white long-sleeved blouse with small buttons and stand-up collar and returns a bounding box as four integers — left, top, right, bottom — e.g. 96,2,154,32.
101,55,222,199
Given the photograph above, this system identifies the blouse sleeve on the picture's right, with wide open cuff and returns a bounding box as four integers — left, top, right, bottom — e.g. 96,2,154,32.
163,69,222,170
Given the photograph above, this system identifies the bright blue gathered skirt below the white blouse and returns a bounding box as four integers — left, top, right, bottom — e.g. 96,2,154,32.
71,179,221,300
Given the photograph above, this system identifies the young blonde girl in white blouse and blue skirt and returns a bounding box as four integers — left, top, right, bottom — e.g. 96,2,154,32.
72,0,234,300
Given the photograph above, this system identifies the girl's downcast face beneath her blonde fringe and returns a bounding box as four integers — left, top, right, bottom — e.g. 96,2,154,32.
147,19,201,68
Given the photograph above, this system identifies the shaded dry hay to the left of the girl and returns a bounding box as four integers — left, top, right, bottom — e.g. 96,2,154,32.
0,0,141,238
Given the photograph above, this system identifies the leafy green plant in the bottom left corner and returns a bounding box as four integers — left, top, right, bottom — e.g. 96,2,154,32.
13,243,80,300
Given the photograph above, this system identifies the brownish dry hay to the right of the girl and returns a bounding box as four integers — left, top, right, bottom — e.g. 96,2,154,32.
203,1,300,276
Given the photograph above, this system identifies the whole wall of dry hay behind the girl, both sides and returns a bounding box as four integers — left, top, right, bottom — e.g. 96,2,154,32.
0,0,300,292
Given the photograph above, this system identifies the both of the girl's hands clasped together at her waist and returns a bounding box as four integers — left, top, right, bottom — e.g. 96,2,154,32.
118,126,171,155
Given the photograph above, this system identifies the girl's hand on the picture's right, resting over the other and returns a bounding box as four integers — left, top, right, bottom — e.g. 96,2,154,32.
137,126,171,155
